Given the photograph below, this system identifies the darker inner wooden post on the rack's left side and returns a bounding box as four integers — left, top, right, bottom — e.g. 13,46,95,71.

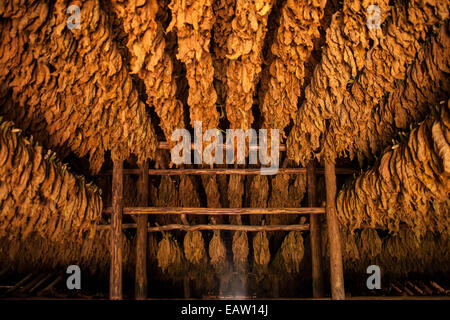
135,161,148,300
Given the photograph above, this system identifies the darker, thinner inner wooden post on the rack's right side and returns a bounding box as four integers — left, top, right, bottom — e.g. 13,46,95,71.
307,161,323,298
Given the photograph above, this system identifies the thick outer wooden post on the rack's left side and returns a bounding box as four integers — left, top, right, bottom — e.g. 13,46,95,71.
109,160,123,300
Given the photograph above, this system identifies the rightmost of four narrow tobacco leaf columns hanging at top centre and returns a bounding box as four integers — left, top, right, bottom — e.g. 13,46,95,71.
261,0,326,137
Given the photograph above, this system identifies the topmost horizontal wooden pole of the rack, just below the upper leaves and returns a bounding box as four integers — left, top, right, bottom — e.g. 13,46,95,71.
100,168,360,176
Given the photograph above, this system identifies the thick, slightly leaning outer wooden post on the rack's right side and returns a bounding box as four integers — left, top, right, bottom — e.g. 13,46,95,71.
325,157,345,300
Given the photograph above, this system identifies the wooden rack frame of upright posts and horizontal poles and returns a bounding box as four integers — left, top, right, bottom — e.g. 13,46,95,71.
103,142,348,300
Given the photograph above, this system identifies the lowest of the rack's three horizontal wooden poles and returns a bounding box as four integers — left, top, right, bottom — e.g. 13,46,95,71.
97,224,309,232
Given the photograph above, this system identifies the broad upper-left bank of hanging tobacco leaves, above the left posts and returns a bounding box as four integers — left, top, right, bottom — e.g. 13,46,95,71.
0,0,156,173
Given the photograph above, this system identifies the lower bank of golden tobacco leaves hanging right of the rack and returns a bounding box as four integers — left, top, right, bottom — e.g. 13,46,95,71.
337,104,450,238
